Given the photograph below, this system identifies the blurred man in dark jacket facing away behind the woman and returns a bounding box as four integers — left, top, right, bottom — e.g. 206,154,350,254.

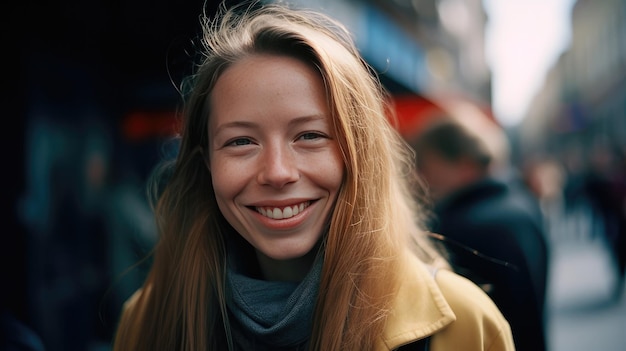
409,117,548,351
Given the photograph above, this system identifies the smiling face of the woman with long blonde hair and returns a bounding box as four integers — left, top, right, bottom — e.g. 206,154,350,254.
209,55,344,266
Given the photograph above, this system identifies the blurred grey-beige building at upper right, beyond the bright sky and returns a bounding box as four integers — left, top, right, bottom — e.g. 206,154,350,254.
520,0,626,159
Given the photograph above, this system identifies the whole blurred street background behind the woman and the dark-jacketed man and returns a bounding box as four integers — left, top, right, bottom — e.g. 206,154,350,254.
0,0,626,351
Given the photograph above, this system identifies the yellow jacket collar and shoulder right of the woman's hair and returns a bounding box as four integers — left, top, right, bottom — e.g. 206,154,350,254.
375,254,515,351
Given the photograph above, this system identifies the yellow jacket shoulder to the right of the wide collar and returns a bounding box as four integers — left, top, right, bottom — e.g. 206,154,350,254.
431,270,515,351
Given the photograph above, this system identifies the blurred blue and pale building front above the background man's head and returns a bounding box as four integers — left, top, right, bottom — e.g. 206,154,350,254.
286,0,491,99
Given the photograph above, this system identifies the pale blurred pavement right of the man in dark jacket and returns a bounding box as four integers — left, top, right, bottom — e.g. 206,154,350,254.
548,236,626,351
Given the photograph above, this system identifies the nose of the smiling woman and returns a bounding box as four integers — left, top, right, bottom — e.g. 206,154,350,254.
257,147,300,189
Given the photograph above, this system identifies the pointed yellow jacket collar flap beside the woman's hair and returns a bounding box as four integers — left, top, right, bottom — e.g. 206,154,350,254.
375,255,456,351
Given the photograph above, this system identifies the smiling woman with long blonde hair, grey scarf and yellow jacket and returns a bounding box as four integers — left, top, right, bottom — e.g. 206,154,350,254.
114,5,513,351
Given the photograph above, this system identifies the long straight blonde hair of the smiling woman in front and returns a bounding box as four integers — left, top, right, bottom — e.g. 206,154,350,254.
115,1,441,351
